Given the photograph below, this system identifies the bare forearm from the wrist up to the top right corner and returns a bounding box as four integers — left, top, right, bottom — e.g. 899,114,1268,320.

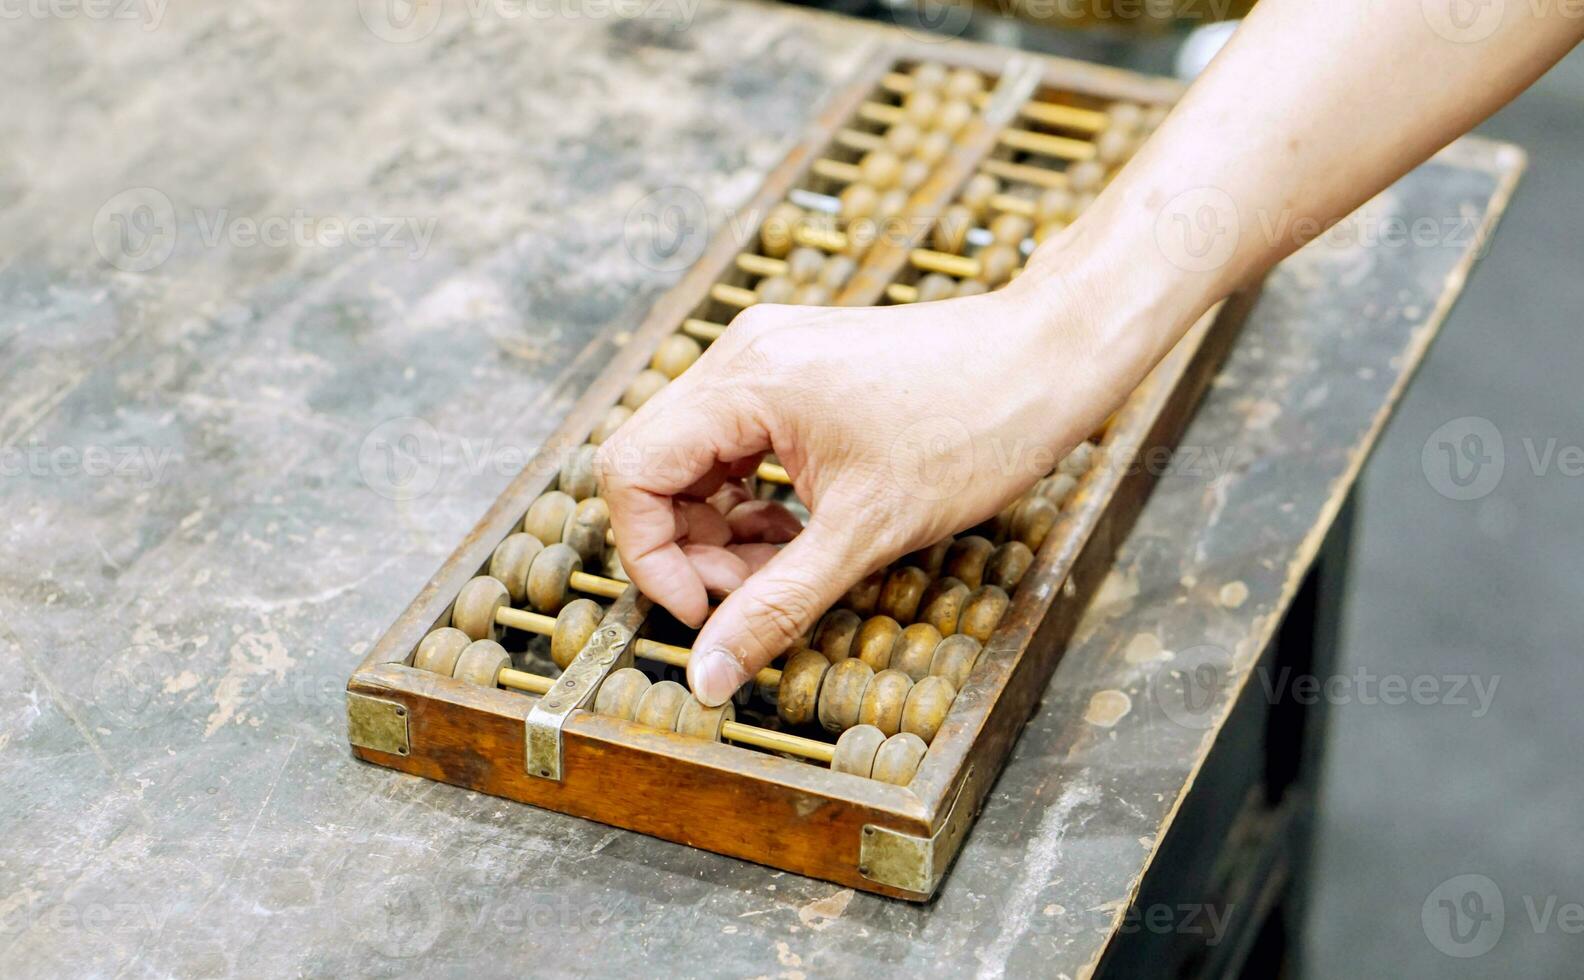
1020,0,1584,375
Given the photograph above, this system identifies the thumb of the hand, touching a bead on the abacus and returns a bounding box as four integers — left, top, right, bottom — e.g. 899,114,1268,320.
687,518,865,706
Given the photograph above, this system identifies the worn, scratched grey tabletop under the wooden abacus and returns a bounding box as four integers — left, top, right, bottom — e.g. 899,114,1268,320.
0,0,1522,977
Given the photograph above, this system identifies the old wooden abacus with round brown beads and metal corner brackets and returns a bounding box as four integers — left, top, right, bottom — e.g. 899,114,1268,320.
347,43,1251,899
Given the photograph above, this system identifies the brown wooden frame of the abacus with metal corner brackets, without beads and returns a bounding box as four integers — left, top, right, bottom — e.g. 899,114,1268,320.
347,43,1253,899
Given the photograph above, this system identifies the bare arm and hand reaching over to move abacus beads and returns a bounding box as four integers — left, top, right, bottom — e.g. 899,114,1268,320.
599,0,1584,705
